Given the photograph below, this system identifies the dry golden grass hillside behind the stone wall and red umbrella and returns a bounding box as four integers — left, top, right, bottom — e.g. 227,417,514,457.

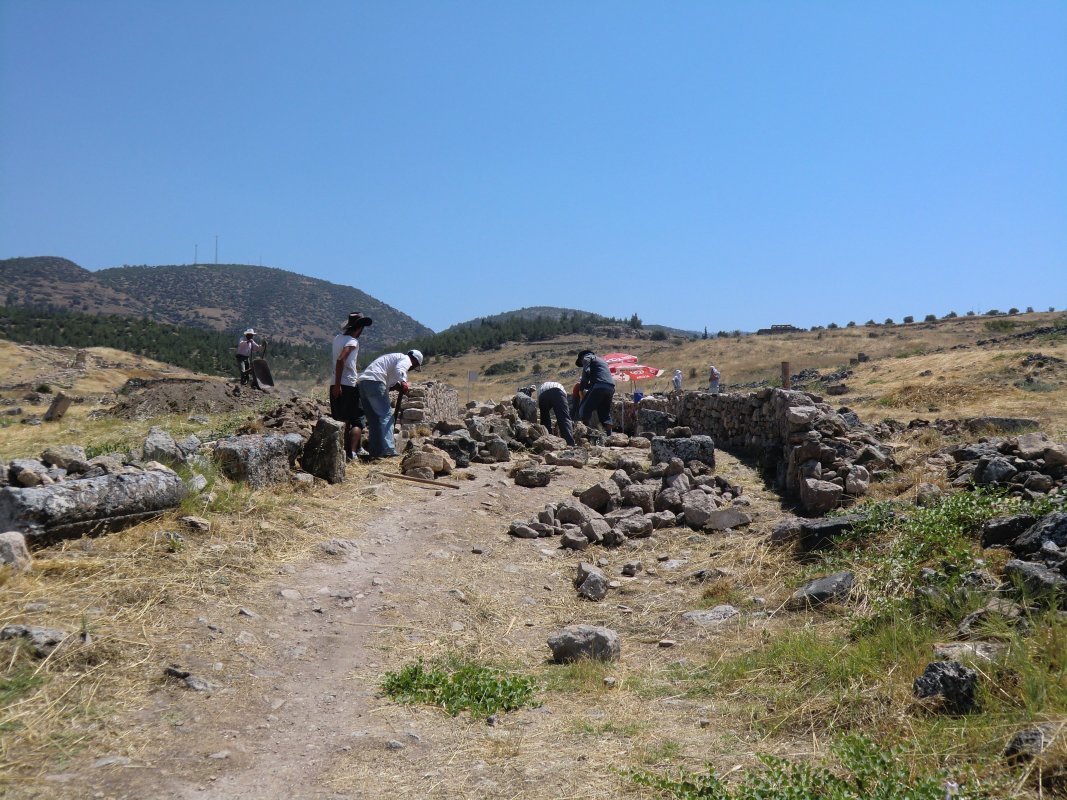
409,313,1067,436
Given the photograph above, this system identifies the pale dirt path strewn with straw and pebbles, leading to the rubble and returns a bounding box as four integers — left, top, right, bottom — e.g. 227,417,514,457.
33,457,777,800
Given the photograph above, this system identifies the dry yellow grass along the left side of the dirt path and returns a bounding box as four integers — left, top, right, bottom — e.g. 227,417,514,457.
0,466,388,794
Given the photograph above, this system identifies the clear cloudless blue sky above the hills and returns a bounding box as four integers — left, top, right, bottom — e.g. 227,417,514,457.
0,0,1067,332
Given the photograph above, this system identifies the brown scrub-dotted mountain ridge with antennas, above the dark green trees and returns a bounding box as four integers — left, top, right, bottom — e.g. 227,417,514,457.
0,256,433,350
